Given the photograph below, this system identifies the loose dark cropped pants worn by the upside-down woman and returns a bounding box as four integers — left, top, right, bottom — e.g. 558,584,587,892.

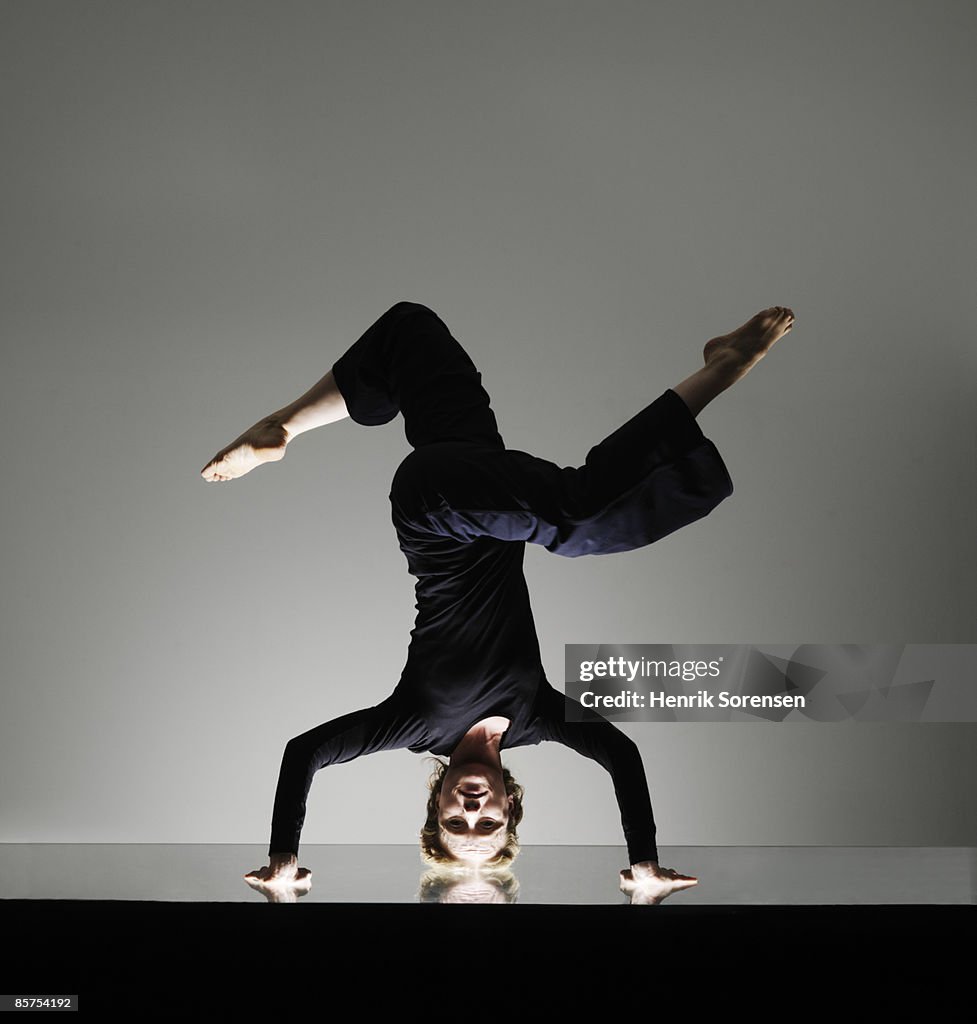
333,302,732,573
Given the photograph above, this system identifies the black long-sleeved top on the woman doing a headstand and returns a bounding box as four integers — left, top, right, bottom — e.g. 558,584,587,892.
269,539,657,863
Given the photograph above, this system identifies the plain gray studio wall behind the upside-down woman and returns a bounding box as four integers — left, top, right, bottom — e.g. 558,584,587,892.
0,0,977,846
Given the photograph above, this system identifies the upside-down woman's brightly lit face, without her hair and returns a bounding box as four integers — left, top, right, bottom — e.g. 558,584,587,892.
437,762,512,863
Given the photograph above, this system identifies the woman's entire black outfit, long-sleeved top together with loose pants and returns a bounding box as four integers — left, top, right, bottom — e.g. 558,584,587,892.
269,302,732,863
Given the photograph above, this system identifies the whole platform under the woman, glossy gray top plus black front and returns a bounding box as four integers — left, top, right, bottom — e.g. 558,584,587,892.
0,845,977,1007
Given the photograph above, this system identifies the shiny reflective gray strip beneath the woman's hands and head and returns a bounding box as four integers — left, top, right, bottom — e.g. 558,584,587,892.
0,844,977,906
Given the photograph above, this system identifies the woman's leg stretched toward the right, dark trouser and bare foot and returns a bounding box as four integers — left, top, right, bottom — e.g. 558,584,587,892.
390,306,794,557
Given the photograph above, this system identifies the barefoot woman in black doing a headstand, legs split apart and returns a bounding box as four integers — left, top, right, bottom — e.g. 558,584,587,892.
202,302,794,901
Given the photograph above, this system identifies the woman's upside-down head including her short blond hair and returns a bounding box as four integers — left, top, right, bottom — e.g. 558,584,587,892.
421,758,522,866
